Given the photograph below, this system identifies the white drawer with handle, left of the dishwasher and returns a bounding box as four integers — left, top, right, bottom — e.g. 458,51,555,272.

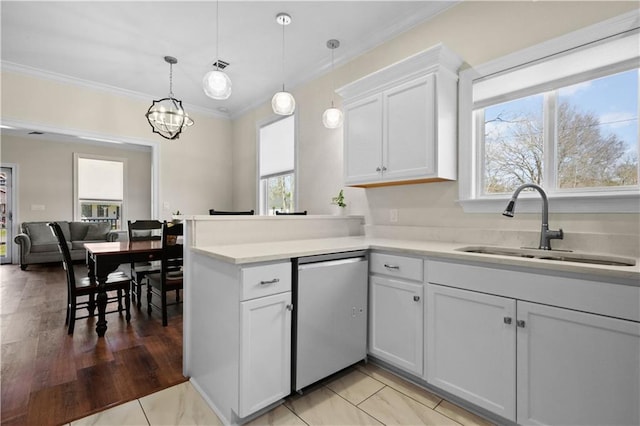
240,262,291,300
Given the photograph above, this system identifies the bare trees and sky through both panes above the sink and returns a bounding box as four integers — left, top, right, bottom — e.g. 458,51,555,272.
480,69,638,194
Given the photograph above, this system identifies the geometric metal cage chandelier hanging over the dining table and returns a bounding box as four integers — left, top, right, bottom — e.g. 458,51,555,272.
145,56,193,139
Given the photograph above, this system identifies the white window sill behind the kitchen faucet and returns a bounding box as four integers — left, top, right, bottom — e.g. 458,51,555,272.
458,191,640,214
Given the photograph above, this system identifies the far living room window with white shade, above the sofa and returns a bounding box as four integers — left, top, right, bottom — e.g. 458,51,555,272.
74,154,126,230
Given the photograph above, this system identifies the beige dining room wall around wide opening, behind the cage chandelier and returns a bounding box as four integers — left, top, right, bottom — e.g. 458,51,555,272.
1,71,232,220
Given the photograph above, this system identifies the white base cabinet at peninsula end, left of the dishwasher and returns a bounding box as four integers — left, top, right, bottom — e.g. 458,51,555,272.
185,252,295,424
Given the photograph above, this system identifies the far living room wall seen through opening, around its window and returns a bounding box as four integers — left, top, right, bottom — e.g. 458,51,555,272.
1,136,151,222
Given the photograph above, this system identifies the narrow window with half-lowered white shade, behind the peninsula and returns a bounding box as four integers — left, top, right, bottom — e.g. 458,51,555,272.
258,116,296,215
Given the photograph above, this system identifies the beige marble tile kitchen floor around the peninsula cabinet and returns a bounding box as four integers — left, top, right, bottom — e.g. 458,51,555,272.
70,363,491,426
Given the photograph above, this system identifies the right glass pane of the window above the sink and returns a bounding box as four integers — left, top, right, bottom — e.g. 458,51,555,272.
556,69,638,189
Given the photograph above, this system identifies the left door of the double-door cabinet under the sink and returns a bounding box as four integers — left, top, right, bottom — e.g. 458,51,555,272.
426,284,516,420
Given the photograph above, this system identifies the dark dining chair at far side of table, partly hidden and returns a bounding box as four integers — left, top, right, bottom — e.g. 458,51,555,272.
127,219,162,309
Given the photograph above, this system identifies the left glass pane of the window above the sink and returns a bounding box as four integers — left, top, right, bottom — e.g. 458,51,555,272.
482,94,544,194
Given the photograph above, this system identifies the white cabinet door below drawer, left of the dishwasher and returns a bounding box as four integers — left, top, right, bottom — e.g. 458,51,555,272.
238,292,291,417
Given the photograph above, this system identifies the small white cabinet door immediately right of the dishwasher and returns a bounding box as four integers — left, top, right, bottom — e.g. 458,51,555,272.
369,275,424,376
